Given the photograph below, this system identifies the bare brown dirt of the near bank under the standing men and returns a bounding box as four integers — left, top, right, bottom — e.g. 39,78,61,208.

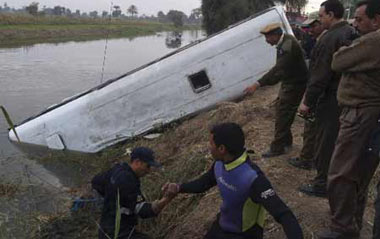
158,87,374,239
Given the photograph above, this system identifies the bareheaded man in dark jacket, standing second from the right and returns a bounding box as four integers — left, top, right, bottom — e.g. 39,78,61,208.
299,0,355,197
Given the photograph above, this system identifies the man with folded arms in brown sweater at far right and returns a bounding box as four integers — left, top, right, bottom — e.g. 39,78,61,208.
319,0,380,239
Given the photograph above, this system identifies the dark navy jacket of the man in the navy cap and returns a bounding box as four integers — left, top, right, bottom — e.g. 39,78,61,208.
91,163,156,238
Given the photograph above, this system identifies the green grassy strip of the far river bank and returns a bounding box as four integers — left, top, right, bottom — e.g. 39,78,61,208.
0,14,200,47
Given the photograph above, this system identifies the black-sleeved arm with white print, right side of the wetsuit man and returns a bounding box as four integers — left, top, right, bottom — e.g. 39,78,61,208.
250,174,303,239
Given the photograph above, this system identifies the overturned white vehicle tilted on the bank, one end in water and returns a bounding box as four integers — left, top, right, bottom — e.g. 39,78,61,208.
9,7,292,153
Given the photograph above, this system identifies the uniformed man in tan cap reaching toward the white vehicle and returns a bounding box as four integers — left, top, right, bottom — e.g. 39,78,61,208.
244,23,308,158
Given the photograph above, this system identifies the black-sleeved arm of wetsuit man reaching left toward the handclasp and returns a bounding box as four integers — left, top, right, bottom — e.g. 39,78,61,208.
179,163,216,193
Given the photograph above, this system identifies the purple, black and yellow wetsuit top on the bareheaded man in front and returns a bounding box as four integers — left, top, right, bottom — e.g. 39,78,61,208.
180,153,303,239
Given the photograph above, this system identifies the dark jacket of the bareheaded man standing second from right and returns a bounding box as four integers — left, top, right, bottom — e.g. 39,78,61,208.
305,21,355,107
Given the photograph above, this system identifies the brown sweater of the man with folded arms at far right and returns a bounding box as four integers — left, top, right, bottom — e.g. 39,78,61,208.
332,30,380,107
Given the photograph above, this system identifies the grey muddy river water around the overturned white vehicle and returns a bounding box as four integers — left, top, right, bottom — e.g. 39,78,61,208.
0,31,204,238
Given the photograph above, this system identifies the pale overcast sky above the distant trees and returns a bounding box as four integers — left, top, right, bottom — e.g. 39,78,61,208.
5,0,323,15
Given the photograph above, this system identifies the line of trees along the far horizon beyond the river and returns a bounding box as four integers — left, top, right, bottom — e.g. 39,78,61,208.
0,0,359,34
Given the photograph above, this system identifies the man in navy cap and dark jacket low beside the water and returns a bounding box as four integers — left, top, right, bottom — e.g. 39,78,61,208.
91,147,174,239
